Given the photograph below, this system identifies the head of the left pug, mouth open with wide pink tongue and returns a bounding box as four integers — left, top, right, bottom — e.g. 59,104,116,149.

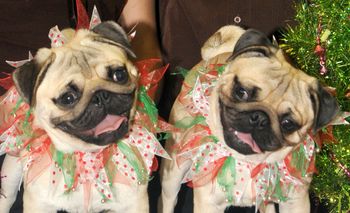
13,22,138,151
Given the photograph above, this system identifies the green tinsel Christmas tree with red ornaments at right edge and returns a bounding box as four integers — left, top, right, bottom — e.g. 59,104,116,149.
282,0,350,213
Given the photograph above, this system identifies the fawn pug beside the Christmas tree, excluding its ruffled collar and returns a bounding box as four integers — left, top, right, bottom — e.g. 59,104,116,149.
159,26,338,213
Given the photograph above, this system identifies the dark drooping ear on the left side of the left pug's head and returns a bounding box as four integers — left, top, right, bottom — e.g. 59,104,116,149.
12,48,51,105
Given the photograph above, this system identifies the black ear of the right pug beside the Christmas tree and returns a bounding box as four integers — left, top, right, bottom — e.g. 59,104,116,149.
311,84,339,133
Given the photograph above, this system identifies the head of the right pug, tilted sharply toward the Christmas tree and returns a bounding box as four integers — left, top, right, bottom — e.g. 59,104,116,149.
218,30,338,154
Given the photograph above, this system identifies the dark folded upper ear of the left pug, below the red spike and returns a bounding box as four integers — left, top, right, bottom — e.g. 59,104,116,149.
92,21,136,58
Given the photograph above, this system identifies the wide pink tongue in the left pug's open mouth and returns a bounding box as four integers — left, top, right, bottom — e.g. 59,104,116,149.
94,115,127,136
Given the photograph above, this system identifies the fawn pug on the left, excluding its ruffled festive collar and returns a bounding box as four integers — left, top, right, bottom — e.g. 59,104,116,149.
0,21,149,213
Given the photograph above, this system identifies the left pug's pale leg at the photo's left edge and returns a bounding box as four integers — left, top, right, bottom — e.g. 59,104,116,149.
0,155,23,212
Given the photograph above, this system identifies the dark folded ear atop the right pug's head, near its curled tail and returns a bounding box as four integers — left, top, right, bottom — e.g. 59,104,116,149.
227,29,276,61
